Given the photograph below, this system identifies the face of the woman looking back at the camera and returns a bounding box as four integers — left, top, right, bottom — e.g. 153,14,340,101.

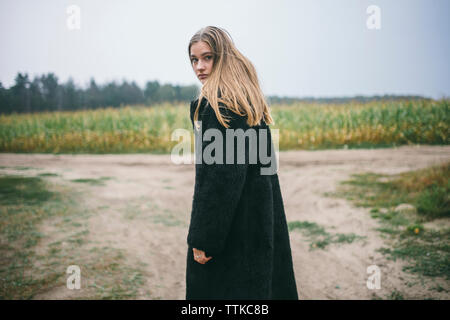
191,41,214,84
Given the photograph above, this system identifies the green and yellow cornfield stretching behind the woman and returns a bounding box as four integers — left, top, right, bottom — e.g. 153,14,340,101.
0,99,450,153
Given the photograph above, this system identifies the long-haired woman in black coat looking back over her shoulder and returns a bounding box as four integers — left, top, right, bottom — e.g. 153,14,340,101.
186,26,298,299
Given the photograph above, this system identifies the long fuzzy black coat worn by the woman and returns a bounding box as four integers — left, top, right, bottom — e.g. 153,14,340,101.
186,98,298,299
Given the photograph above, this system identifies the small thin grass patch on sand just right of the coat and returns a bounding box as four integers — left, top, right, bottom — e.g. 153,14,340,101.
288,221,366,250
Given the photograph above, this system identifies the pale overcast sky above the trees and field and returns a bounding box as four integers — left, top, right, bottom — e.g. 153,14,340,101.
0,0,450,98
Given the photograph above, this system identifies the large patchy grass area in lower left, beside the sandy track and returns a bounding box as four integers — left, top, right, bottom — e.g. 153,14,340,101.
0,176,145,300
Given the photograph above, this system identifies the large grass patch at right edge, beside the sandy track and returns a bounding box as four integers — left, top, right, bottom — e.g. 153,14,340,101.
335,163,450,282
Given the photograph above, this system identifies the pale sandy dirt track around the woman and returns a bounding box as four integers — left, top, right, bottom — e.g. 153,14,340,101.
0,146,450,299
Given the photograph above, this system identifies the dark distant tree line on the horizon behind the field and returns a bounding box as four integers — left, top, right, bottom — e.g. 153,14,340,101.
0,72,428,114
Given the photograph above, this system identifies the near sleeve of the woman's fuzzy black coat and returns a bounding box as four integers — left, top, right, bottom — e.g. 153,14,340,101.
187,107,248,256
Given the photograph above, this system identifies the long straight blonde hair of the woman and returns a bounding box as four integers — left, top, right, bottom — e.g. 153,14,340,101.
188,26,275,128
